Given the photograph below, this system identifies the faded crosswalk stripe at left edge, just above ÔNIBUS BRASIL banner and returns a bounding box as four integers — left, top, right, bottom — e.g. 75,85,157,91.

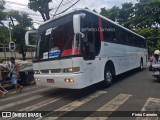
0,95,44,110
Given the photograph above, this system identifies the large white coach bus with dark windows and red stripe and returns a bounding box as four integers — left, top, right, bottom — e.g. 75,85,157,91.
25,9,148,89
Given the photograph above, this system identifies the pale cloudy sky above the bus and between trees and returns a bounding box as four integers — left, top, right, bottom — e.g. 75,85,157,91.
3,0,137,24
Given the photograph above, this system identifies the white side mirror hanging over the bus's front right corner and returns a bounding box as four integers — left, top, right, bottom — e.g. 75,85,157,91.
73,13,86,35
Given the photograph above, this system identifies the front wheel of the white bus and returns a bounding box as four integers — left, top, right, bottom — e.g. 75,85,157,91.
104,68,113,87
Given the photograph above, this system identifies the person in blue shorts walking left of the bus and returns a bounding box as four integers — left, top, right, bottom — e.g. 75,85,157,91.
10,57,23,94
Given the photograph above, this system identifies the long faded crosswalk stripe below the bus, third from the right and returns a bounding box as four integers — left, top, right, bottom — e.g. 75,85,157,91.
36,91,107,120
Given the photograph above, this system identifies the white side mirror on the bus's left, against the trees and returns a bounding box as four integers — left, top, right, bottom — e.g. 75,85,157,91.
25,30,38,47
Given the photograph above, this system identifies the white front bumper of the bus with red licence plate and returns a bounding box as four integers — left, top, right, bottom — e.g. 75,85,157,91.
34,73,89,89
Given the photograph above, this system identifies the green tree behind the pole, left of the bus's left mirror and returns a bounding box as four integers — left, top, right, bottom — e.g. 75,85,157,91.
9,12,32,60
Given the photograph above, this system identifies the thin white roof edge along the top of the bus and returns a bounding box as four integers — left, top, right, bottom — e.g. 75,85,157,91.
40,9,145,39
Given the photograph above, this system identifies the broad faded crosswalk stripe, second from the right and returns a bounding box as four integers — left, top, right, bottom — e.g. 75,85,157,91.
84,94,132,120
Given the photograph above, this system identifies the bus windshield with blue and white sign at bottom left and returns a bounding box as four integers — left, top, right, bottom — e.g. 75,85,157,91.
39,21,80,59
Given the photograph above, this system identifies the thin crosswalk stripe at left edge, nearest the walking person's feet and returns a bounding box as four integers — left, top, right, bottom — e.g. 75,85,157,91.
0,88,51,102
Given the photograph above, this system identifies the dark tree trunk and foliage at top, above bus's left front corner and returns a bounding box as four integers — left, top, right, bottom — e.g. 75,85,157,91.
28,0,52,21
